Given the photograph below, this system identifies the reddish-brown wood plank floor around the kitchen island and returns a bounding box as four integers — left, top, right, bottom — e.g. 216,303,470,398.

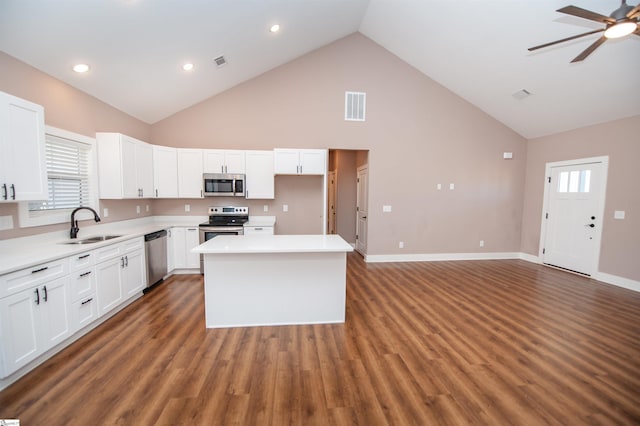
0,254,640,426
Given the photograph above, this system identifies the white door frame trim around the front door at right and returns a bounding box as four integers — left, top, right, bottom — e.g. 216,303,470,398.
538,155,609,271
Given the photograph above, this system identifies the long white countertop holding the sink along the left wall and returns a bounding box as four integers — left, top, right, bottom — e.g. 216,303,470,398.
0,216,206,275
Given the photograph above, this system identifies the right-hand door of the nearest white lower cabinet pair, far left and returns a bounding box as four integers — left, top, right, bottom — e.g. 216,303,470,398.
39,276,71,352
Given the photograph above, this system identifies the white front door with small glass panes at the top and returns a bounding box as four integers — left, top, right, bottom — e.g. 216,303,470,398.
542,159,607,275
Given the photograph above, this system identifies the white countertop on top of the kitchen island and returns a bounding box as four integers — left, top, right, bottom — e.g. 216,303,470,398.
191,235,353,254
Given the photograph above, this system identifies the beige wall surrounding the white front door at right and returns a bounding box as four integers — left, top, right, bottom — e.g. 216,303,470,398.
522,116,640,280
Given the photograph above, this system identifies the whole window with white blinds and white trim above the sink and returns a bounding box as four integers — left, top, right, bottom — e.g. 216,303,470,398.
20,127,97,227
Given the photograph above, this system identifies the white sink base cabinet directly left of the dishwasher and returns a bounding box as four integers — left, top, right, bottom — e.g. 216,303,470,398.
96,237,146,316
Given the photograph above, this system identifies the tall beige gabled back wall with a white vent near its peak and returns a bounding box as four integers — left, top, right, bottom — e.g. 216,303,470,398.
152,34,526,254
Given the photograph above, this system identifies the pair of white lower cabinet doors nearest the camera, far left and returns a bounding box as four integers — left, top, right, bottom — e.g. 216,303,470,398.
0,275,72,377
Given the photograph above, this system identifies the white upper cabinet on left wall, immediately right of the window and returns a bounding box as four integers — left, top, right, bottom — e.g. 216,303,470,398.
96,133,154,199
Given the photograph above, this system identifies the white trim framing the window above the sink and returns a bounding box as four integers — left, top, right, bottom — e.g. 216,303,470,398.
18,126,98,228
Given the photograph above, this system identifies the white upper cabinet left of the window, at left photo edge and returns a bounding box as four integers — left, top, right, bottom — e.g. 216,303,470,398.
0,92,48,202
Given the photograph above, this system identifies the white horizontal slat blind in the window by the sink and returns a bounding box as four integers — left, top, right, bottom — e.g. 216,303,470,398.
29,134,93,214
